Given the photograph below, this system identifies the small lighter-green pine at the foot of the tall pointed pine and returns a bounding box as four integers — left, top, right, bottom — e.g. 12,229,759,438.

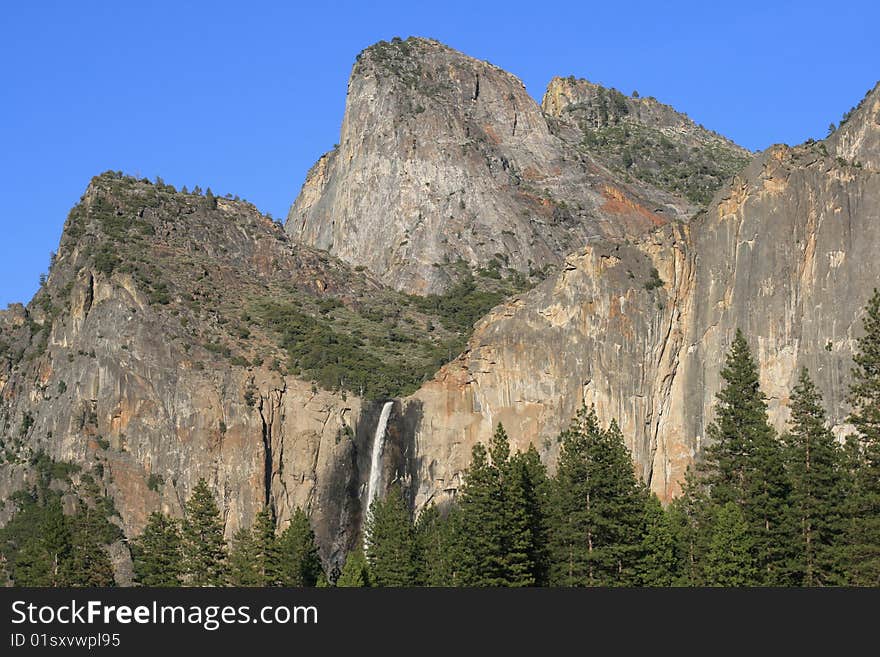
705,502,758,586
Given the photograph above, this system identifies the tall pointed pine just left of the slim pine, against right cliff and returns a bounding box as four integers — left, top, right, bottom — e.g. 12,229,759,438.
702,329,795,585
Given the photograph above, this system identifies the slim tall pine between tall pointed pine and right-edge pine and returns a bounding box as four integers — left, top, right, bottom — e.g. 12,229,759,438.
783,368,844,586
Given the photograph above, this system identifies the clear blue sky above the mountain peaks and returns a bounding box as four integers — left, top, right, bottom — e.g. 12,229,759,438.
0,0,880,307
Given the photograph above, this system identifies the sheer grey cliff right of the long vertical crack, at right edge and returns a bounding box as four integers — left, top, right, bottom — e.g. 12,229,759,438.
683,138,880,456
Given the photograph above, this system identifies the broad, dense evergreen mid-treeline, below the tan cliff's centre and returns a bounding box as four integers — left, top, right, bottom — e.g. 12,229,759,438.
550,406,646,586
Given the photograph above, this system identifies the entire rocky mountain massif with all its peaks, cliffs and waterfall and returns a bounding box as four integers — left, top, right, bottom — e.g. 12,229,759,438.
0,38,880,583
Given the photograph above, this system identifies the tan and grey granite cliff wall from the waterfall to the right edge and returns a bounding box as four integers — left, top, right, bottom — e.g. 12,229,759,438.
413,82,880,502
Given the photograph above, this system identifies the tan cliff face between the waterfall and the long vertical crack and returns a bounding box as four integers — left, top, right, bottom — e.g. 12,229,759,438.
411,233,692,502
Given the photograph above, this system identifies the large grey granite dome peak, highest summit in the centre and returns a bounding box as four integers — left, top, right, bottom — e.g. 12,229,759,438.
286,39,692,294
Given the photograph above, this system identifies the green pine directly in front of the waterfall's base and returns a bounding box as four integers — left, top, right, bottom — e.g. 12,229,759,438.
365,485,418,587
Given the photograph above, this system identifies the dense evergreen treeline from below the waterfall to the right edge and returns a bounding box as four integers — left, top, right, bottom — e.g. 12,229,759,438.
348,292,880,586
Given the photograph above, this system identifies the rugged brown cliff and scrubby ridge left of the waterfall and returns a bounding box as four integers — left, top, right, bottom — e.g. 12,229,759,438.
0,174,434,562
